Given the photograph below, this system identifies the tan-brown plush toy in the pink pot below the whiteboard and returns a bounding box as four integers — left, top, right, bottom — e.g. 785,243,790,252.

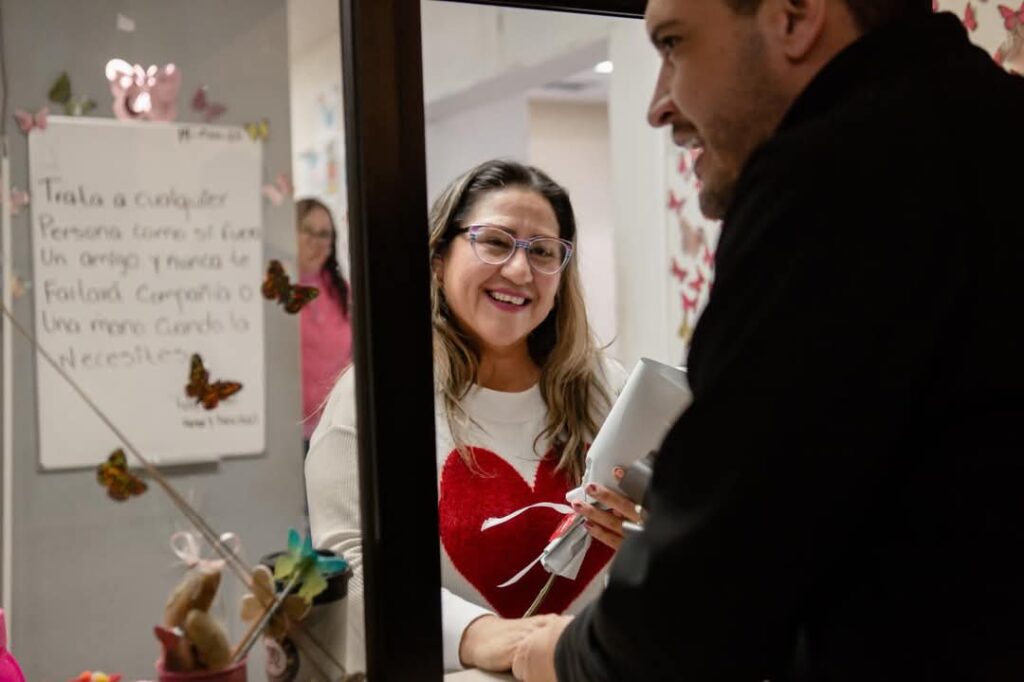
155,567,231,672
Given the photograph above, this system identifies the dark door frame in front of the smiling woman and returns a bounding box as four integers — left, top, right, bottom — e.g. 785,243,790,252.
339,0,645,682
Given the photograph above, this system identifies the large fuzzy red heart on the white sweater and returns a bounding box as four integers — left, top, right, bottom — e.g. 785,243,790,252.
438,447,612,617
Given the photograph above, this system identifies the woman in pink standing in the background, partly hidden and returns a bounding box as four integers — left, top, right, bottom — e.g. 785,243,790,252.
295,199,352,450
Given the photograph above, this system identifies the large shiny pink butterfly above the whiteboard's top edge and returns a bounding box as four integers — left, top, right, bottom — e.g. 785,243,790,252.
104,58,181,121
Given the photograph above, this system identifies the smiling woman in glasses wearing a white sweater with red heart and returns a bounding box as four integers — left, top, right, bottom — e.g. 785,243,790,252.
306,161,637,671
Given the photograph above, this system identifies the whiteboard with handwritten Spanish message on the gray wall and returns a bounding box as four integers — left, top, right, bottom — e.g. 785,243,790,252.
29,117,265,469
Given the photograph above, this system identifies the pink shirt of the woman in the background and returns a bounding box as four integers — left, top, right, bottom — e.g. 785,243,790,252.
299,270,352,440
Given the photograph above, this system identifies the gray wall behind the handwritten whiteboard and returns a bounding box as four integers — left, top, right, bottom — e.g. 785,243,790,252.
2,0,303,682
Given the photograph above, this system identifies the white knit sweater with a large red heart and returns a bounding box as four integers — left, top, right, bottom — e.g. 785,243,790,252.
305,361,626,672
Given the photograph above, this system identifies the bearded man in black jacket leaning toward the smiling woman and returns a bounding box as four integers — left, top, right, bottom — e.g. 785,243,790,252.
513,0,1024,682
